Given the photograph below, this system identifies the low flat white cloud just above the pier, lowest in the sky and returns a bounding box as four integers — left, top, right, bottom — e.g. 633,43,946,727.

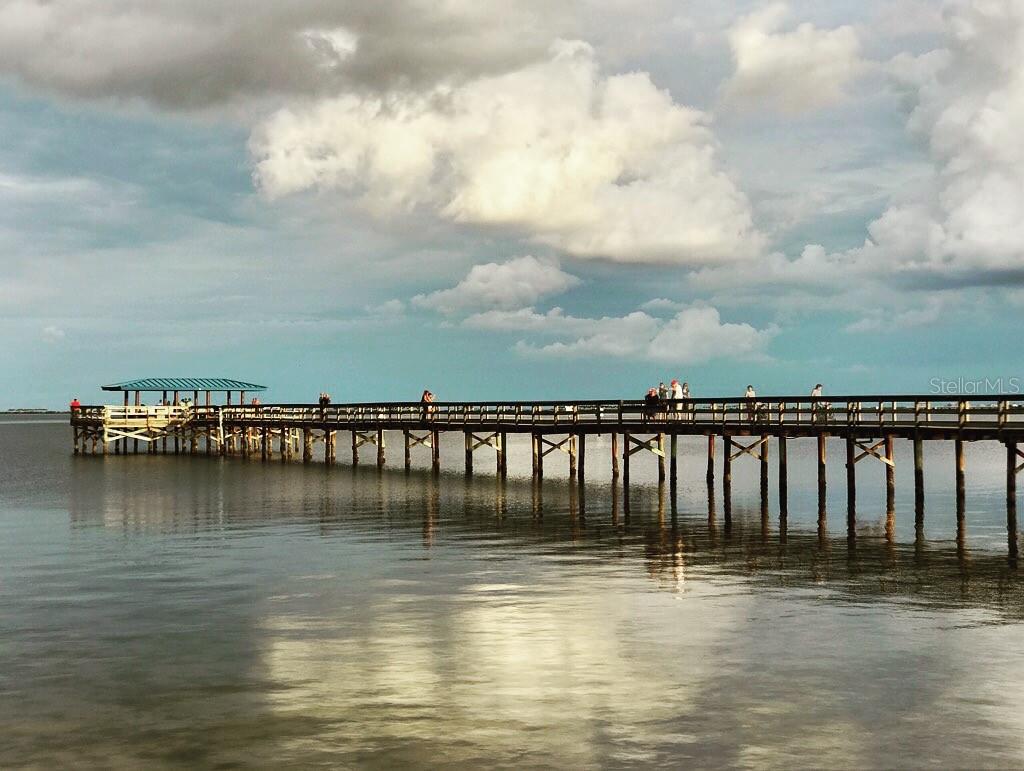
464,306,777,363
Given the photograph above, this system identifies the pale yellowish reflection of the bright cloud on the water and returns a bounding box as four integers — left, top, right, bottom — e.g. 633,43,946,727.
263,573,745,766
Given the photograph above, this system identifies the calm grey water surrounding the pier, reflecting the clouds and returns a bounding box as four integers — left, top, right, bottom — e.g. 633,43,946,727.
0,419,1024,768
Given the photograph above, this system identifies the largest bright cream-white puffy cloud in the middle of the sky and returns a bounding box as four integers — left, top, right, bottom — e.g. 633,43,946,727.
251,41,761,264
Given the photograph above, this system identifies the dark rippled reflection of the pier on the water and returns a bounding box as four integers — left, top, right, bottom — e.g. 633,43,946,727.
71,464,1024,620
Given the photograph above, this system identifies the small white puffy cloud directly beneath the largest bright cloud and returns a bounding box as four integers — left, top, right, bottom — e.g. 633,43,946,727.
413,256,580,313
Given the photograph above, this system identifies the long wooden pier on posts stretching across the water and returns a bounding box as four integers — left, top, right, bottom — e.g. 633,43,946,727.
71,391,1024,559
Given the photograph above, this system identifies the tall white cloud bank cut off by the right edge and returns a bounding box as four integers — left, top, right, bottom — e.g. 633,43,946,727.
691,0,1024,294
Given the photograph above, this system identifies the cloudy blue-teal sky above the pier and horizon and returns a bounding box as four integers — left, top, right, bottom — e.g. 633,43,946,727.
0,0,1024,409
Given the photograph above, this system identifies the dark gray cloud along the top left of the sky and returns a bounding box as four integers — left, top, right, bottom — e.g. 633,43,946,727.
0,0,572,110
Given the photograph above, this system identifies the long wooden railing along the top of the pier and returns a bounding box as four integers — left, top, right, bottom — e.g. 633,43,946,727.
72,395,1024,430
